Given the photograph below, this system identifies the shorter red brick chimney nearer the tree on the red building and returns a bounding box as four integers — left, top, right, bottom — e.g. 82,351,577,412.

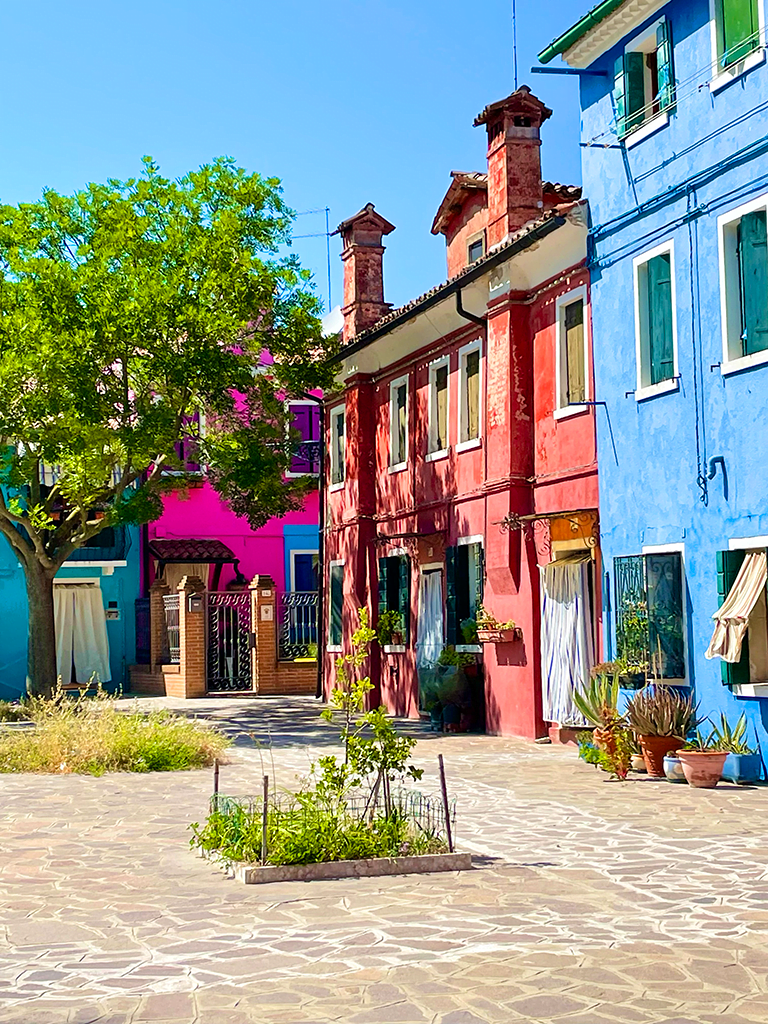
334,203,394,344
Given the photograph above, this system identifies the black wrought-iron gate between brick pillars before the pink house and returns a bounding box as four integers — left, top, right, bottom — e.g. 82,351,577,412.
206,591,253,693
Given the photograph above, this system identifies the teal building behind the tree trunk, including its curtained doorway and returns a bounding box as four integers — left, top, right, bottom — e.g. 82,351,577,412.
0,526,141,700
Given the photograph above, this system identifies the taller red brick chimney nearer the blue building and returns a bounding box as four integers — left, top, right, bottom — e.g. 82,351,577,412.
474,85,552,248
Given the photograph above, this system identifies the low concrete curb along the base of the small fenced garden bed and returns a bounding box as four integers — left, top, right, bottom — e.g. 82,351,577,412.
204,851,472,885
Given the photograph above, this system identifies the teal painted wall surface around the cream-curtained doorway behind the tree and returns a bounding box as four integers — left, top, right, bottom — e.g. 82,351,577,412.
0,527,140,700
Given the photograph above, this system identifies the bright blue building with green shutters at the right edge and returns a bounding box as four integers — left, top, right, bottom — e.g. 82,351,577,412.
540,0,768,757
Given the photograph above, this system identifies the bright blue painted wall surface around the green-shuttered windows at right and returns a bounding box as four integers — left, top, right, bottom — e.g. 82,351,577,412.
581,0,768,759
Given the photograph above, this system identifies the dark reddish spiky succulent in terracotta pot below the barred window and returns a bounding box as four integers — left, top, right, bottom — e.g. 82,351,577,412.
627,683,696,778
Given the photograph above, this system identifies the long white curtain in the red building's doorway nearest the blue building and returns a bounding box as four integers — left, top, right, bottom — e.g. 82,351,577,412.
540,555,594,725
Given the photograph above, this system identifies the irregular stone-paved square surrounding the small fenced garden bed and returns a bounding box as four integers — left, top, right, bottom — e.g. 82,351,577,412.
0,698,768,1024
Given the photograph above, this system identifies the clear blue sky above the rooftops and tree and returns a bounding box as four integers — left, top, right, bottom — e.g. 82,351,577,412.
0,0,581,304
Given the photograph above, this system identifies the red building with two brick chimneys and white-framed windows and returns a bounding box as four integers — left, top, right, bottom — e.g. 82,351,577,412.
324,86,601,737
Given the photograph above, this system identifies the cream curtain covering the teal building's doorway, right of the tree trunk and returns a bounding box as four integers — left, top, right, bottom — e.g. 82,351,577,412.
53,584,112,686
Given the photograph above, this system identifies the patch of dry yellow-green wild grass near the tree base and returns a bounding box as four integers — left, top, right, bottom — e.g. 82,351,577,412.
0,690,229,775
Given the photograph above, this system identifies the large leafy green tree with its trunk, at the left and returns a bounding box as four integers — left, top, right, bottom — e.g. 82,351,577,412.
0,158,328,694
